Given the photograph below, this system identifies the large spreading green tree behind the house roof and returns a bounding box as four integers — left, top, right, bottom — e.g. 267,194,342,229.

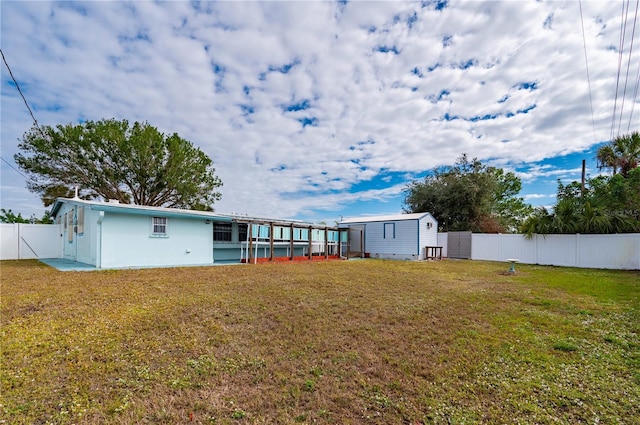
15,119,222,210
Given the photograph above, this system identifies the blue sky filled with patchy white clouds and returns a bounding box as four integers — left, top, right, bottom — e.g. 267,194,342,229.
0,0,640,223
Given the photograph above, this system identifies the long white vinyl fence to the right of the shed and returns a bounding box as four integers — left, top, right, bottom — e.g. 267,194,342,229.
438,233,640,270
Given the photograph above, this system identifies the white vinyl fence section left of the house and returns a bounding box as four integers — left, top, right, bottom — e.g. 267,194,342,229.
0,223,62,260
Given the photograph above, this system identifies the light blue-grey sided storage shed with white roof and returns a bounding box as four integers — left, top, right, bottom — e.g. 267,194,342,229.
339,213,438,260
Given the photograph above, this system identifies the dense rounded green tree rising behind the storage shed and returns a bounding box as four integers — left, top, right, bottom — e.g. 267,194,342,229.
404,154,533,233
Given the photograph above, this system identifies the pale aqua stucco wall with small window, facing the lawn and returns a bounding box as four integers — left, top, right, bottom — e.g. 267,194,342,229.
98,212,213,268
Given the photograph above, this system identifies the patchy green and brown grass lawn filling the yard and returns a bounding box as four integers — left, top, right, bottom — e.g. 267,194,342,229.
0,260,640,424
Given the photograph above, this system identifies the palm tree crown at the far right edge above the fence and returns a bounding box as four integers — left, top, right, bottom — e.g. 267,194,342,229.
596,131,640,177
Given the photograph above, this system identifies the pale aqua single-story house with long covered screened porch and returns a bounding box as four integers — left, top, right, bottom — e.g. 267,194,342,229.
51,198,346,268
